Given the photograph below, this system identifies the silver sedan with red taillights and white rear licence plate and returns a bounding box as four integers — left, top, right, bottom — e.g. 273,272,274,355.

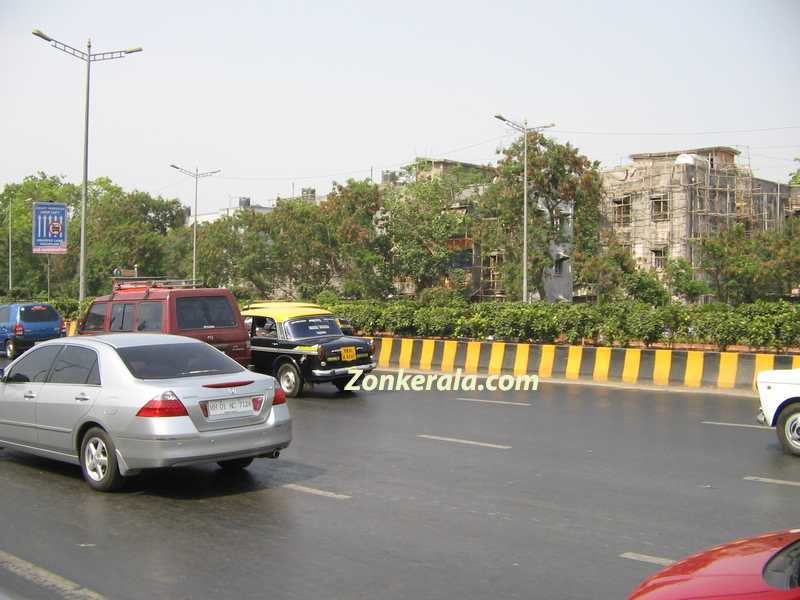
0,333,292,491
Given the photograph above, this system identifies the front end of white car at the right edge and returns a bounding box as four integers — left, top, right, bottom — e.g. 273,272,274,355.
756,369,800,456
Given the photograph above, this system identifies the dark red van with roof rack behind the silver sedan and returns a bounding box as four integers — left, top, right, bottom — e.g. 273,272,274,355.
77,279,251,366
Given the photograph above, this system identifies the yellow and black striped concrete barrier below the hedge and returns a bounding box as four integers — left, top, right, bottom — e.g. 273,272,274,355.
374,337,800,389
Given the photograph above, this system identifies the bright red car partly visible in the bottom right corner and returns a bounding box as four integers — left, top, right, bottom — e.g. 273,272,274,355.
628,529,800,600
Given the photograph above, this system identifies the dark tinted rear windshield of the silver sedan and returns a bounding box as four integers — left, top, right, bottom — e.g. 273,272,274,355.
117,344,244,379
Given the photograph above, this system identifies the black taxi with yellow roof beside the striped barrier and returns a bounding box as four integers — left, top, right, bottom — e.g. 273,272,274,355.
242,302,376,398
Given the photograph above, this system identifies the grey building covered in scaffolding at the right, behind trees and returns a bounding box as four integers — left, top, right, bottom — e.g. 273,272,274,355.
602,146,796,271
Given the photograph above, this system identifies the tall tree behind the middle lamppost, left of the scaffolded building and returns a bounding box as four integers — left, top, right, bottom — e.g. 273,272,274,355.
477,133,602,297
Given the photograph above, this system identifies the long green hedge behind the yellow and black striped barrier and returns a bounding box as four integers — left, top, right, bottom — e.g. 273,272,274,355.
326,300,800,350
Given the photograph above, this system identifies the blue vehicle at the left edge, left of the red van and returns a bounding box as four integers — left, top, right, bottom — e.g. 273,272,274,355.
0,304,64,359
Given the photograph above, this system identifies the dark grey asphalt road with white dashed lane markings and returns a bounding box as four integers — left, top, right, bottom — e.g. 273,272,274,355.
0,372,800,600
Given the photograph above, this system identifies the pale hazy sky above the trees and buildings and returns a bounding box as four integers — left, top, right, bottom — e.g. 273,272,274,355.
0,0,800,213
